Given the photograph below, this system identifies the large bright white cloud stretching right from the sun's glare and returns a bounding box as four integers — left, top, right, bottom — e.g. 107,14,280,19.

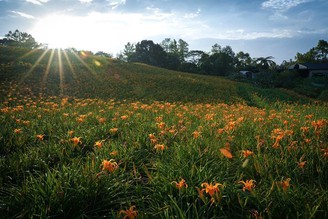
31,8,294,54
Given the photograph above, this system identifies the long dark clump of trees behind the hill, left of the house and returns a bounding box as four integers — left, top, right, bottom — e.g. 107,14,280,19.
118,38,276,76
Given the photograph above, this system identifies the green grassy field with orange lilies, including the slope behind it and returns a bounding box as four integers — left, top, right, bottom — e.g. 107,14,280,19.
0,46,328,218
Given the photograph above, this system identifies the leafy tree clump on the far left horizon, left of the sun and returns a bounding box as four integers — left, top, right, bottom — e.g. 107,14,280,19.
1,30,40,49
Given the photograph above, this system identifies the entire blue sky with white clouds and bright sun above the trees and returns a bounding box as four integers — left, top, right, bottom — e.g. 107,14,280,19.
0,0,328,64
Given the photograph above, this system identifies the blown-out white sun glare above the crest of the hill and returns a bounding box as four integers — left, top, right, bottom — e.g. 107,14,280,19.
29,12,138,53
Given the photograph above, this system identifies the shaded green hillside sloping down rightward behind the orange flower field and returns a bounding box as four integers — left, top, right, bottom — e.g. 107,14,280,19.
0,47,309,106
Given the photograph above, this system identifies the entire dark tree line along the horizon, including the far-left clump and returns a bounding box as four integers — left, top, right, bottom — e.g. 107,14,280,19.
0,30,328,76
